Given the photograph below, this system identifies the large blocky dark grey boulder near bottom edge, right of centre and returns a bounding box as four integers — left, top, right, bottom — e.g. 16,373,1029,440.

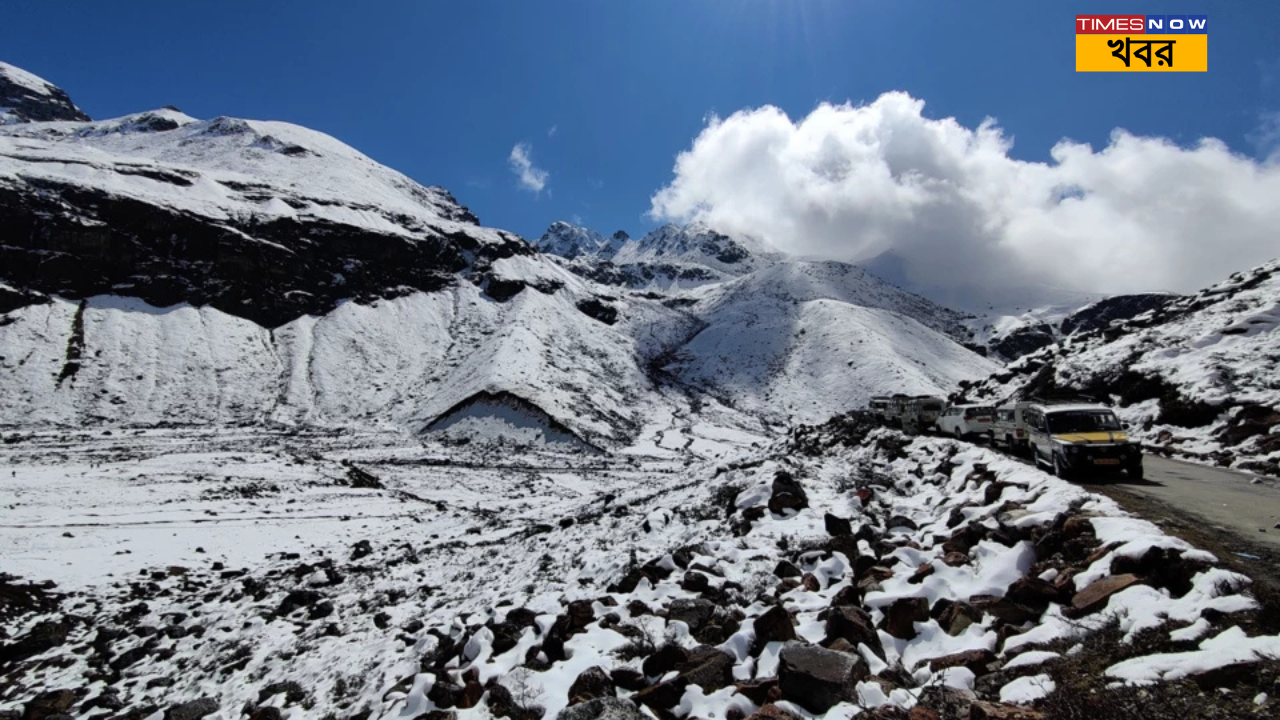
778,644,870,714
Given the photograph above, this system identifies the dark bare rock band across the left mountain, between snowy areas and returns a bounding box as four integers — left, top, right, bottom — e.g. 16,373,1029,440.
0,174,532,327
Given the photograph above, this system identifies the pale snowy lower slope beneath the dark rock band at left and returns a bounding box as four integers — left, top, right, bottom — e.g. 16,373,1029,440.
0,271,711,443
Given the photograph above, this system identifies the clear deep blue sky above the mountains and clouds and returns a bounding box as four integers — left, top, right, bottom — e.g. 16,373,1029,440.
0,0,1280,237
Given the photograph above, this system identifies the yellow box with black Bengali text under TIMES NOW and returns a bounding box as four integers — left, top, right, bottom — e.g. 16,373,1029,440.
1075,35,1208,73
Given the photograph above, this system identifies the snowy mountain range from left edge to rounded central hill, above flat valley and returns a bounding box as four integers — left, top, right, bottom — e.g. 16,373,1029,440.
0,61,995,447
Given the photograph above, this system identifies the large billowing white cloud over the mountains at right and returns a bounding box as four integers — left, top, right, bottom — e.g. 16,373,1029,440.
650,92,1280,301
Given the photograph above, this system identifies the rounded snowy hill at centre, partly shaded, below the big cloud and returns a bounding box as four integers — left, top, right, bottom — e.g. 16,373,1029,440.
671,261,998,423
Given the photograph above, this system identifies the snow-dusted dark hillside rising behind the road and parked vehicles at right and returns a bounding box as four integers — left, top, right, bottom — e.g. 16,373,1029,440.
966,261,1280,475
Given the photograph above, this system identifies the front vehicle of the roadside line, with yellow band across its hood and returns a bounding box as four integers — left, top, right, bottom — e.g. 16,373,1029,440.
1023,401,1142,480
